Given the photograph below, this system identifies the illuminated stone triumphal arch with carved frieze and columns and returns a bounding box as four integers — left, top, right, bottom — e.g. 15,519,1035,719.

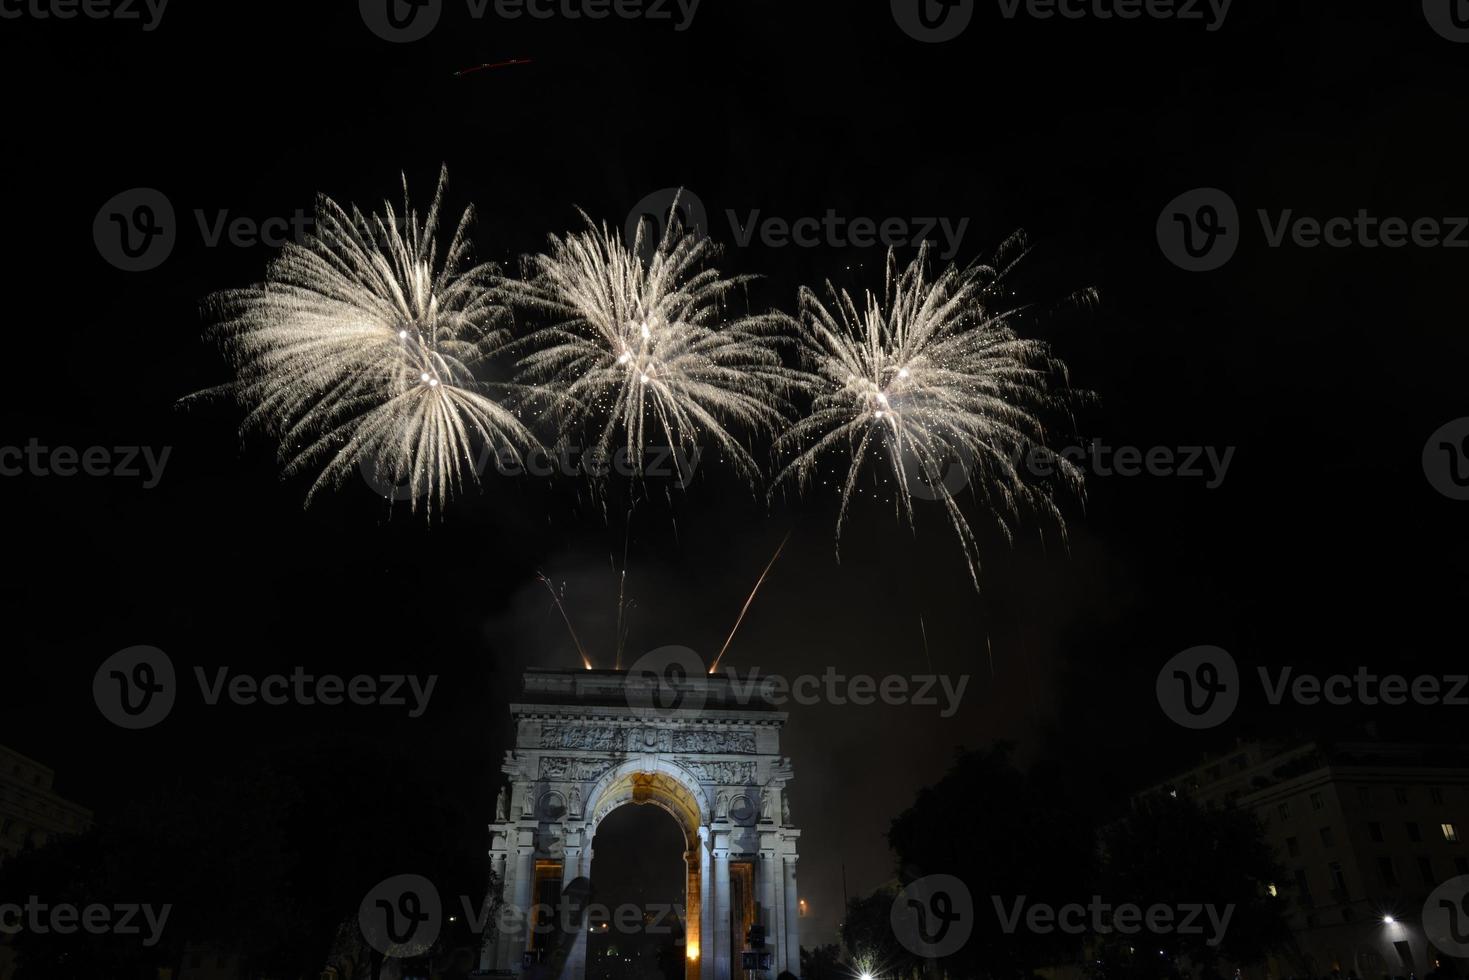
480,661,801,980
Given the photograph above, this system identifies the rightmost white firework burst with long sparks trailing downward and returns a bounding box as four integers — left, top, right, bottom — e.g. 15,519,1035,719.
776,235,1083,589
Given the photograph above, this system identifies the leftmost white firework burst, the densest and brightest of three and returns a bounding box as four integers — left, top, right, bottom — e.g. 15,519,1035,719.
201,172,535,513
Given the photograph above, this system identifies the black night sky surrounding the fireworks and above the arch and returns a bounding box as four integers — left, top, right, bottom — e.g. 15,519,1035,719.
0,0,1469,943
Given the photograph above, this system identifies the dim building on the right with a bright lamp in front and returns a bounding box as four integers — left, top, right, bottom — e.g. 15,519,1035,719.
1149,741,1469,980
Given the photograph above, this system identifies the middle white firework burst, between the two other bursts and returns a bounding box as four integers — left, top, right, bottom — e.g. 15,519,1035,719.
505,203,792,482
